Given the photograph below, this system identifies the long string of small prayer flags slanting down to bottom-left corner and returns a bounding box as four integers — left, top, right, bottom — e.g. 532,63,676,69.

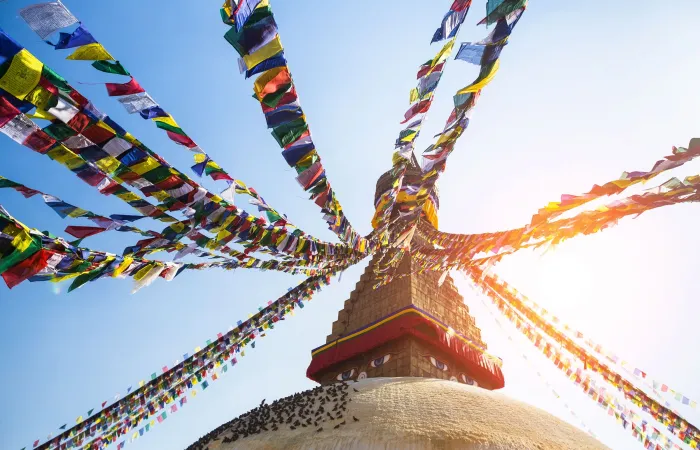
29,266,342,450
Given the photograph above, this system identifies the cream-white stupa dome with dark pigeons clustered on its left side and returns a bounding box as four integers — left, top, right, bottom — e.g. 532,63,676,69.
190,378,607,450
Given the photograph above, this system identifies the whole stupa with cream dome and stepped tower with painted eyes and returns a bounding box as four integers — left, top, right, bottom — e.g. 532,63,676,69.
188,166,606,450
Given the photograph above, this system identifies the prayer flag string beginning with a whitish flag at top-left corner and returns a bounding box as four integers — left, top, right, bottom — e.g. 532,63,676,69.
20,2,298,230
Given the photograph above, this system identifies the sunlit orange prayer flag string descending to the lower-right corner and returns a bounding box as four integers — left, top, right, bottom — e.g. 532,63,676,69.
469,268,700,448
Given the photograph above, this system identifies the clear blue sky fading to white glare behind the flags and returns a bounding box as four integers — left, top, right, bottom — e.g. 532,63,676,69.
0,0,700,450
